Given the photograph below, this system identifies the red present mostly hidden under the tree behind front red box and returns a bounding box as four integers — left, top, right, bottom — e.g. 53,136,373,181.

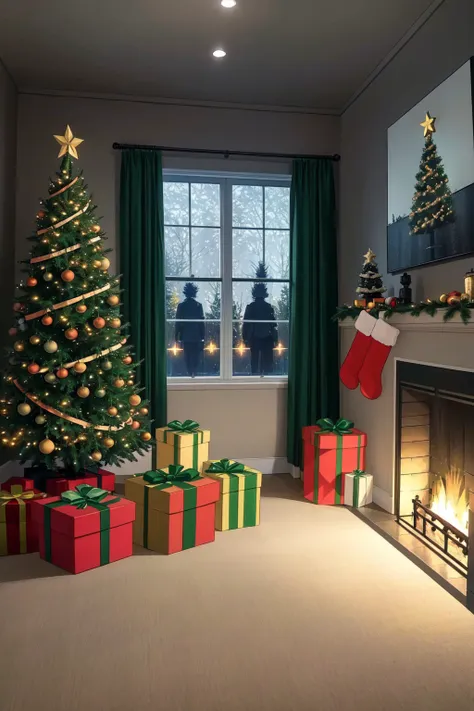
25,465,115,496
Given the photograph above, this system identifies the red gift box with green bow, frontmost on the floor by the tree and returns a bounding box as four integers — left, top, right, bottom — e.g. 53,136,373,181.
32,484,135,573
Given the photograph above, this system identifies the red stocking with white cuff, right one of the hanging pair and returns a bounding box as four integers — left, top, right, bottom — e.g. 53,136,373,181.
359,319,400,400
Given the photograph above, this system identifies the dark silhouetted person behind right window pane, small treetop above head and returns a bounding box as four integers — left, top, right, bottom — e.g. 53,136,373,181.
242,262,278,375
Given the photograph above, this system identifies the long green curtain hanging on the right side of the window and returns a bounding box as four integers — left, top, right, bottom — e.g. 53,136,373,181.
287,159,339,467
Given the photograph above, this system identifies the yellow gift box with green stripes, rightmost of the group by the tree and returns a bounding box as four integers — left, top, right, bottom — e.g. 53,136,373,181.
202,459,262,531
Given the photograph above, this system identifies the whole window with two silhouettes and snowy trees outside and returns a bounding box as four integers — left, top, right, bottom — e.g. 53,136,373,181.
164,175,290,380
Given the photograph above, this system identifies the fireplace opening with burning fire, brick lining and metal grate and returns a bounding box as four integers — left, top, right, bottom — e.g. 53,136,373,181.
395,360,474,576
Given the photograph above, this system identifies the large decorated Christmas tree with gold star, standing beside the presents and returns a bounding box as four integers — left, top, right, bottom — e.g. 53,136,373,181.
0,126,151,473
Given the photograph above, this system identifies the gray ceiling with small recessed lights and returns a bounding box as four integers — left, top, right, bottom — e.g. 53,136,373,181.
0,0,439,111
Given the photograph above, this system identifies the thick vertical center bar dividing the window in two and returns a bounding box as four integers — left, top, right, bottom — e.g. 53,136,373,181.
221,178,232,380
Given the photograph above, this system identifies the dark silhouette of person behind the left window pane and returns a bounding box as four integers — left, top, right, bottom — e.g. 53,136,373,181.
175,281,204,378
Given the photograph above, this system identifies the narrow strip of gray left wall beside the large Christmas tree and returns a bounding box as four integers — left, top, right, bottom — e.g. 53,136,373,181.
0,61,17,346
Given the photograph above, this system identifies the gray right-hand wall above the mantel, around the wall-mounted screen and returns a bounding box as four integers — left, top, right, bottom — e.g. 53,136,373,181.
339,0,474,302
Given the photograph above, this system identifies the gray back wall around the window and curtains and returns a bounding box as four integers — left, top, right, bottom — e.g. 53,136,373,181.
16,90,340,473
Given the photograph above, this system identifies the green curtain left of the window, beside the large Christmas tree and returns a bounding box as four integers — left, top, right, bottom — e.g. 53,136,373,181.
120,150,167,427
